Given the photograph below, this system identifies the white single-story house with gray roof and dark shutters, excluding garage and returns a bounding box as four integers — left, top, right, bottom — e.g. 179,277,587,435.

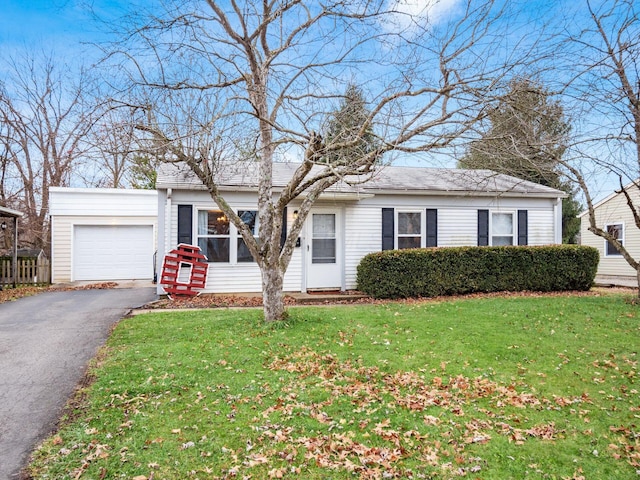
156,163,566,293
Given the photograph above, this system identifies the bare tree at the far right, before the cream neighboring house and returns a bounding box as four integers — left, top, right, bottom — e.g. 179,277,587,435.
564,0,640,295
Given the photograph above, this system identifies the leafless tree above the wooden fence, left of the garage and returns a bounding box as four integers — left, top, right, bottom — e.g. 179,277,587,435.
0,55,97,249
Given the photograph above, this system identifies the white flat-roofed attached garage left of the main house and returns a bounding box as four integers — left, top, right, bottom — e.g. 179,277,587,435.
49,187,158,283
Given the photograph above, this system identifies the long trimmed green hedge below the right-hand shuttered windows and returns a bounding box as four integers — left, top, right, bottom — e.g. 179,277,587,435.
357,245,599,298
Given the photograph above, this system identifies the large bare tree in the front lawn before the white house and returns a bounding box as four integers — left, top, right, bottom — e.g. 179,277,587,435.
110,0,552,321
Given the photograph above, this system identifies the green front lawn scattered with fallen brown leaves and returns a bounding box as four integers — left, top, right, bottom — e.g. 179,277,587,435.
31,296,640,480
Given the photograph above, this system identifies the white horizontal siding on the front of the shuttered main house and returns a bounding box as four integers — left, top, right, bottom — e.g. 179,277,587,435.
158,190,557,293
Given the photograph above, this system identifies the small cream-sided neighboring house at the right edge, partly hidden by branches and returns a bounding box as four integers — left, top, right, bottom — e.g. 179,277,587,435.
578,188,640,286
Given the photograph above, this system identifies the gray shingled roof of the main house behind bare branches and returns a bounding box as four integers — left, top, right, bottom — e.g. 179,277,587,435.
156,163,567,198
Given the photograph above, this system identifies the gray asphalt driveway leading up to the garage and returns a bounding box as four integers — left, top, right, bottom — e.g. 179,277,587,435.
0,287,155,480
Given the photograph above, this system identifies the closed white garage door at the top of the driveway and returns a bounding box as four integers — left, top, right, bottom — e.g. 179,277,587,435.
73,225,153,280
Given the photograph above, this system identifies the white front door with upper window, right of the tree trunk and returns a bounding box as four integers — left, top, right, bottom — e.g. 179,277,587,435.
306,209,342,290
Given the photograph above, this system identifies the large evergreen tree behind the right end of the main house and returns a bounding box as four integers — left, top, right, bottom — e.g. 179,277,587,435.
458,78,581,243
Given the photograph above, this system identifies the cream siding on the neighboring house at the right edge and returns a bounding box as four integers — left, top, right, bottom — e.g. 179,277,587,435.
580,191,640,277
